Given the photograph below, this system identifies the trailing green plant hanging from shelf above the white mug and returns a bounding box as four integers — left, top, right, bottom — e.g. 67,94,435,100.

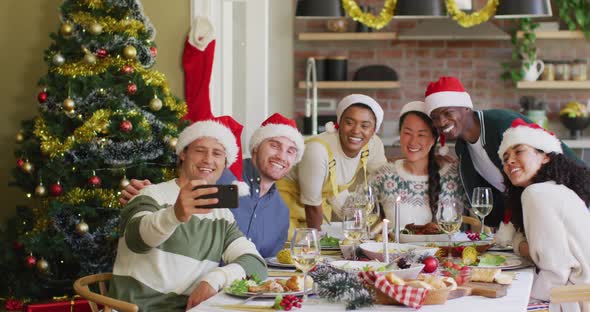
501,18,539,83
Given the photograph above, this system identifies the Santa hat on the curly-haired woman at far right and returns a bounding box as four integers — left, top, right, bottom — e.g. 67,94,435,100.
498,118,563,159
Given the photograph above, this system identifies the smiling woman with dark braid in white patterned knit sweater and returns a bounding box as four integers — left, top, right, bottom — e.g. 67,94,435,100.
371,101,469,225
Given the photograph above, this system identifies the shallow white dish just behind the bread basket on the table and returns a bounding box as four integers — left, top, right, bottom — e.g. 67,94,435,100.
330,260,424,279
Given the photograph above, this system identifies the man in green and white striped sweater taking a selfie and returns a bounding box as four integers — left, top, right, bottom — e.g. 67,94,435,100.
110,116,267,311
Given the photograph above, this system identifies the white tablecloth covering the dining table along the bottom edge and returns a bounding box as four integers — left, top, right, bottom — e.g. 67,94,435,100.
189,268,533,312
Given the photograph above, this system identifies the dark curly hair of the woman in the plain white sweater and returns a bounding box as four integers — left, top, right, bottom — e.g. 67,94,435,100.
502,149,590,228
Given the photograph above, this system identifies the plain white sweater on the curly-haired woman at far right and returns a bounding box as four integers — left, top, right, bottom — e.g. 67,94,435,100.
521,181,590,300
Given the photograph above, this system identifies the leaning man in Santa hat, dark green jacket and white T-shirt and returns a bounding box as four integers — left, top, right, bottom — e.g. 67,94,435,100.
425,77,577,232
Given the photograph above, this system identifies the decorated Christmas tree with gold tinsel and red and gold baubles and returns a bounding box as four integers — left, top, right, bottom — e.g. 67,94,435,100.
0,0,186,300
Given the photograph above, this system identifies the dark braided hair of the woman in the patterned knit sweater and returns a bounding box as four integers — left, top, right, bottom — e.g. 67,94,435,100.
398,111,441,218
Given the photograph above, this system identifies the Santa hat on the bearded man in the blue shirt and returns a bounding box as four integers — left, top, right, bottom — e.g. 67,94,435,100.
250,113,305,163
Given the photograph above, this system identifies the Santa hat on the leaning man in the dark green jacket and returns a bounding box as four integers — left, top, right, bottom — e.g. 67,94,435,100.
424,77,473,115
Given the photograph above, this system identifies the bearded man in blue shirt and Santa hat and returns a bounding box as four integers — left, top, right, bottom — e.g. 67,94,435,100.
120,113,304,258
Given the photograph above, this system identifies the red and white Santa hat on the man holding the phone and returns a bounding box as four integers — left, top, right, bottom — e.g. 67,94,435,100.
176,116,250,196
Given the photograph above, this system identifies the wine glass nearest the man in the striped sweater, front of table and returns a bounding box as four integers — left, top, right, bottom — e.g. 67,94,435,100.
291,228,320,301
